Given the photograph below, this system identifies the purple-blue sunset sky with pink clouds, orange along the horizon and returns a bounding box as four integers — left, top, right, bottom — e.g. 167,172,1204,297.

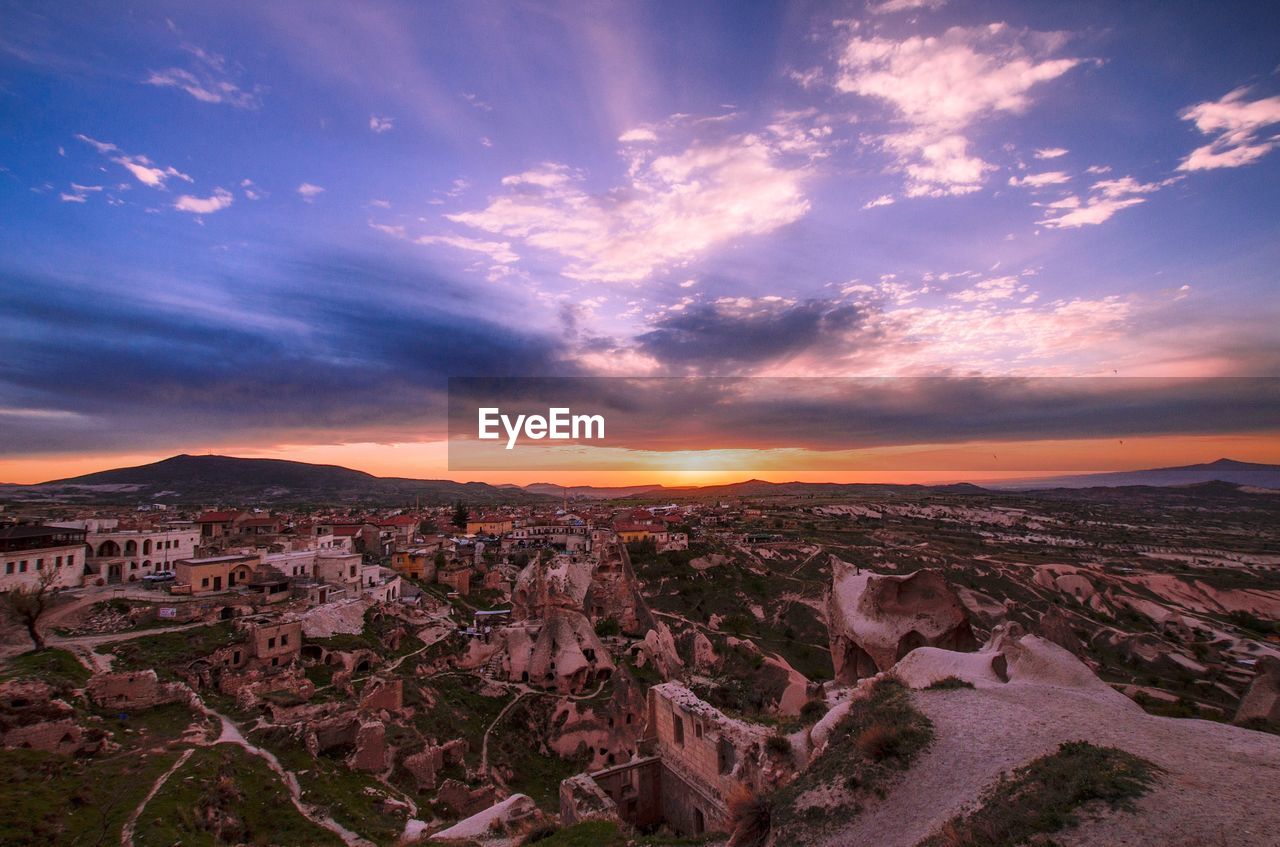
0,0,1280,482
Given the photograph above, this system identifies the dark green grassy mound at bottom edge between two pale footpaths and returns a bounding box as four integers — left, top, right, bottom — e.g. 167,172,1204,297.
134,745,342,847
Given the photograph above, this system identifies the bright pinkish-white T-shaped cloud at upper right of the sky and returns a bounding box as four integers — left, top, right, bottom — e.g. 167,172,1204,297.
836,23,1082,197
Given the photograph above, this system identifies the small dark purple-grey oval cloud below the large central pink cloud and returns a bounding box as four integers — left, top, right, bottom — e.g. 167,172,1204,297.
636,299,864,372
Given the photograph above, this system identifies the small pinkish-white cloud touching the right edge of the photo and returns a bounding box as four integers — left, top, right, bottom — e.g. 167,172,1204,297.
1178,86,1280,170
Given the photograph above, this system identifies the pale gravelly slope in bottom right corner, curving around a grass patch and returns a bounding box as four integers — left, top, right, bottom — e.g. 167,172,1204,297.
827,686,1280,847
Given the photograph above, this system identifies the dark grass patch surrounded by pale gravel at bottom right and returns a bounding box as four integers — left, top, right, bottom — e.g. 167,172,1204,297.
920,741,1158,847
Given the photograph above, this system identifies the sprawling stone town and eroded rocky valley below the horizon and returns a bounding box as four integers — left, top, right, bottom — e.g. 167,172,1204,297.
0,470,1280,844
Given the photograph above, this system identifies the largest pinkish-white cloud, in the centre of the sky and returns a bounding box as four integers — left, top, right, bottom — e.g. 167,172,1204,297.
445,118,822,281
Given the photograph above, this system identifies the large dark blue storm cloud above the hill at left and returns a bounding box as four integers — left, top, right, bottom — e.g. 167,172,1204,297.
0,255,575,454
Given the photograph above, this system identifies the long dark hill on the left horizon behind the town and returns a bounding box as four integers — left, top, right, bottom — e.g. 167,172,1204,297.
4,454,555,505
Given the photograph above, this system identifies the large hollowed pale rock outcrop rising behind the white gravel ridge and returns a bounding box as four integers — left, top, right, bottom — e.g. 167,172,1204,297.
827,560,978,683
